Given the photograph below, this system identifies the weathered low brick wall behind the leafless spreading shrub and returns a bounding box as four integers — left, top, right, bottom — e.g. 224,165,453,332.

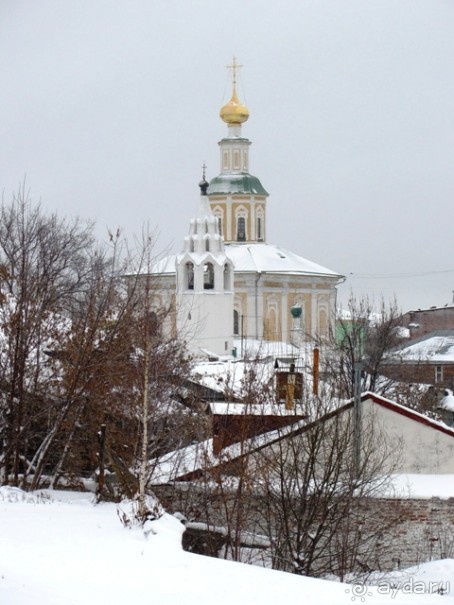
155,484,454,572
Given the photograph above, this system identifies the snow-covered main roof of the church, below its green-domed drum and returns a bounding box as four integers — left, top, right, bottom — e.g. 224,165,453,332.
153,244,342,278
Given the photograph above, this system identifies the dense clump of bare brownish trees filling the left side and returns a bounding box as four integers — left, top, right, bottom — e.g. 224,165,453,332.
0,189,187,494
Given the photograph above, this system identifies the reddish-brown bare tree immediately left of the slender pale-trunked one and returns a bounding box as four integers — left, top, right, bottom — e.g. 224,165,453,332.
29,234,136,488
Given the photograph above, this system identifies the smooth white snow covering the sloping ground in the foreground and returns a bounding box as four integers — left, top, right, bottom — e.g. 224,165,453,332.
0,487,454,605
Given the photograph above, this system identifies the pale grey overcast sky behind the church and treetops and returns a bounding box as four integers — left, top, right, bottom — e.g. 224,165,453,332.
0,0,454,310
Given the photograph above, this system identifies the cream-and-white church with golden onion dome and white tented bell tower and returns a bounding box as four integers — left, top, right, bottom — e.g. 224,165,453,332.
153,62,343,356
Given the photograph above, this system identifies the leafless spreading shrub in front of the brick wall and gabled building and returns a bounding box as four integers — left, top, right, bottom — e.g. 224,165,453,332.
257,399,399,579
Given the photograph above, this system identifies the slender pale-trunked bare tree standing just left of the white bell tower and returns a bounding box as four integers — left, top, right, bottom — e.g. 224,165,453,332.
107,230,193,522
